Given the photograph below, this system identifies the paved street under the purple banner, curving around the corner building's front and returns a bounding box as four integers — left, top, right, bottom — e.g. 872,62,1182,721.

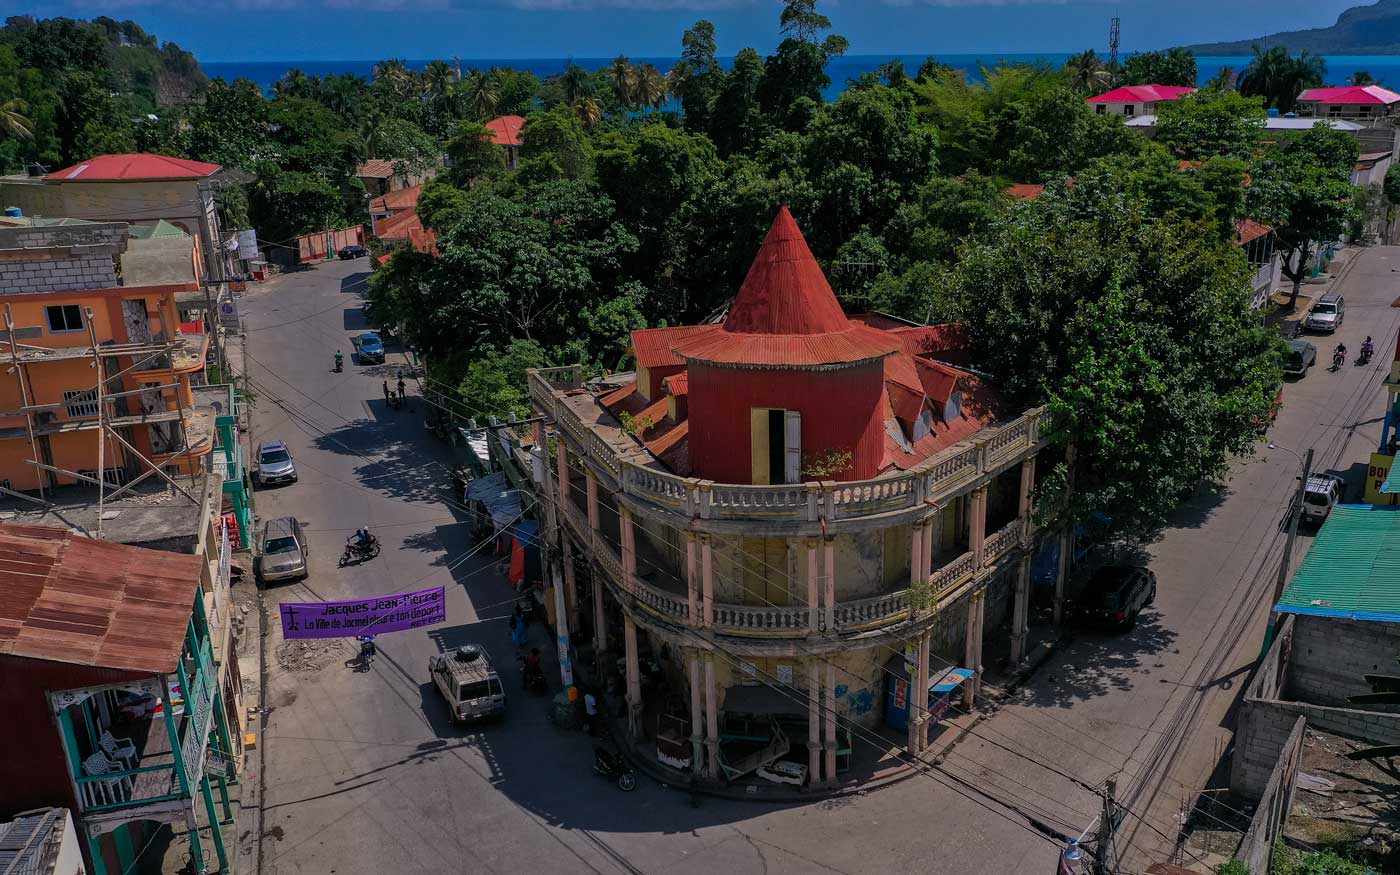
242,260,1058,875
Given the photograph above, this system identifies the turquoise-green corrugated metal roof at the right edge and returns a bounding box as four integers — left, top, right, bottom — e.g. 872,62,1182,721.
1274,504,1400,623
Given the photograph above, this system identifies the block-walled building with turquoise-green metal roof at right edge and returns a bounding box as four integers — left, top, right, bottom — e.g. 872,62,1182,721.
1231,504,1400,799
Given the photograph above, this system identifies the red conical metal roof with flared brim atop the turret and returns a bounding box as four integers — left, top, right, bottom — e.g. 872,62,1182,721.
673,206,899,367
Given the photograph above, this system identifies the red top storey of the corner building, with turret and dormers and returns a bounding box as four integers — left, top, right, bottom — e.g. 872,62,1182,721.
598,207,1002,483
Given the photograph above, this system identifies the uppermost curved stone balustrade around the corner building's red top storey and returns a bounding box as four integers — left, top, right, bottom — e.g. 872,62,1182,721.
529,368,1044,524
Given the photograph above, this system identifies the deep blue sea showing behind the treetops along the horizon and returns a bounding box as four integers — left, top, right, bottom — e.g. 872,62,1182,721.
202,52,1400,99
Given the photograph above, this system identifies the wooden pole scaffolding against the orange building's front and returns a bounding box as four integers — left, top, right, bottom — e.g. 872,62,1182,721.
0,304,213,538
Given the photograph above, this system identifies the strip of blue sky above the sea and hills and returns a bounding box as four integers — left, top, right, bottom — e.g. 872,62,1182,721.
16,0,1357,62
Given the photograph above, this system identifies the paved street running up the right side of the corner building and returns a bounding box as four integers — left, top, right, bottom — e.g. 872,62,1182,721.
951,246,1400,872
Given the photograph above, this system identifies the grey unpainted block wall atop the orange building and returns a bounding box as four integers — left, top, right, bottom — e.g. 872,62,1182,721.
0,223,126,294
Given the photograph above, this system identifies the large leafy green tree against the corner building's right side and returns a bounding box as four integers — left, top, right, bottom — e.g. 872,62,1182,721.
956,171,1281,535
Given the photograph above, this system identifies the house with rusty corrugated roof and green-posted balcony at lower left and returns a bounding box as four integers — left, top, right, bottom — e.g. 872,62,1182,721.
0,524,231,875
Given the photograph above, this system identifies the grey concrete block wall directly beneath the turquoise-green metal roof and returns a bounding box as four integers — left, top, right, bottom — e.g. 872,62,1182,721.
1282,615,1400,713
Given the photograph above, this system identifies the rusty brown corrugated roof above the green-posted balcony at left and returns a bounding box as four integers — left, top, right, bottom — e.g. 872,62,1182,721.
0,524,203,673
